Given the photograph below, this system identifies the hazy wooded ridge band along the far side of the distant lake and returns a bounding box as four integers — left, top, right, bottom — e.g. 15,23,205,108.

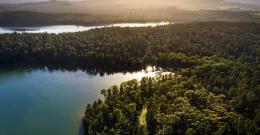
0,7,260,27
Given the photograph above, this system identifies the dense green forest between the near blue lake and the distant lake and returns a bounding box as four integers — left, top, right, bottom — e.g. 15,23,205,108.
0,22,260,135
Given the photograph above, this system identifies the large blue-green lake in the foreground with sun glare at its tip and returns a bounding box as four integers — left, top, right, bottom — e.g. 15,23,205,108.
0,67,167,135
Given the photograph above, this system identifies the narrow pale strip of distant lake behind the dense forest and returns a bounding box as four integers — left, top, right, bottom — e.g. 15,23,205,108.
0,22,170,34
